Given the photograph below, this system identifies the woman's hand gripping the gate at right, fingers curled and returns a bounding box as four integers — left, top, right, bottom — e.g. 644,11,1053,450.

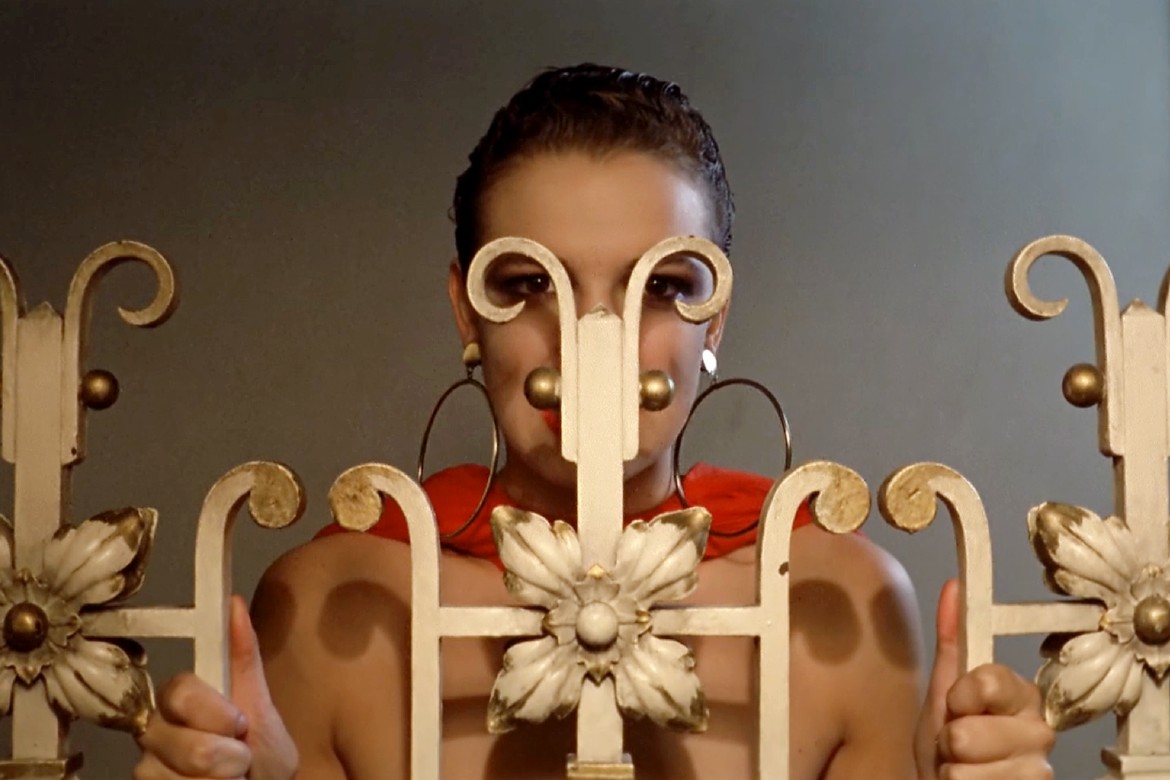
914,580,1055,780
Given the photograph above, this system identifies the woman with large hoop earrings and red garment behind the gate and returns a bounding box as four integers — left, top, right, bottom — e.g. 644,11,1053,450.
136,65,1052,780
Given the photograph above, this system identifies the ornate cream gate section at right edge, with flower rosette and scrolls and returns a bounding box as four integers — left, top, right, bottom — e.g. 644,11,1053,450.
879,235,1170,780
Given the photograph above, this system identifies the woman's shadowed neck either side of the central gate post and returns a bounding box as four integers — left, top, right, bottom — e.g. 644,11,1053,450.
496,453,674,525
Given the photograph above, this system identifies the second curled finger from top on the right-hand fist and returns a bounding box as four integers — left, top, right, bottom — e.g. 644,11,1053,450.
938,715,1055,764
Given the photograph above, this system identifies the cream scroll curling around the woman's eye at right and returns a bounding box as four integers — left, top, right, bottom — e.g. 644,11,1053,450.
621,236,731,461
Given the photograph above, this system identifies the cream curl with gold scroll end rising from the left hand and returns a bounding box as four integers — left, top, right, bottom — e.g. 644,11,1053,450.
194,461,304,692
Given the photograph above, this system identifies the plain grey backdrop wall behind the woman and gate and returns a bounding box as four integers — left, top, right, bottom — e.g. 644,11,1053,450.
0,0,1170,778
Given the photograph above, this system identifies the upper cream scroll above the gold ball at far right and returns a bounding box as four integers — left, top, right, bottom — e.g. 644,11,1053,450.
1004,235,1124,456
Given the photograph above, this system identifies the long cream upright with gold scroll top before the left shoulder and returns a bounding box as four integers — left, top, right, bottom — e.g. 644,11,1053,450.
329,463,439,780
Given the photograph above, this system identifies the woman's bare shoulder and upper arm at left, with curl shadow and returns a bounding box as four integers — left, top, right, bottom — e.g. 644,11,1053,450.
252,533,410,779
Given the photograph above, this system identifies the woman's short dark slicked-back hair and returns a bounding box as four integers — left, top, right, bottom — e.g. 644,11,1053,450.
452,63,735,274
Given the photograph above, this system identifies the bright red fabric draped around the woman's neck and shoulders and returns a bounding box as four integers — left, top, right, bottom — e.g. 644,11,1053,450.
317,463,812,568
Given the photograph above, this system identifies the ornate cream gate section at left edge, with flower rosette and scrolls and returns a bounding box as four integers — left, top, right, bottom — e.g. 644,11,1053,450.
0,241,303,780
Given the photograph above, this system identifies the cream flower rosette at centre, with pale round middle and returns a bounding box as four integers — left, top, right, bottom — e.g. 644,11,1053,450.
488,506,711,733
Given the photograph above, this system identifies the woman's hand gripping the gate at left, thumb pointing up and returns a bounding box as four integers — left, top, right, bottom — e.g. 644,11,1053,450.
133,596,297,780
